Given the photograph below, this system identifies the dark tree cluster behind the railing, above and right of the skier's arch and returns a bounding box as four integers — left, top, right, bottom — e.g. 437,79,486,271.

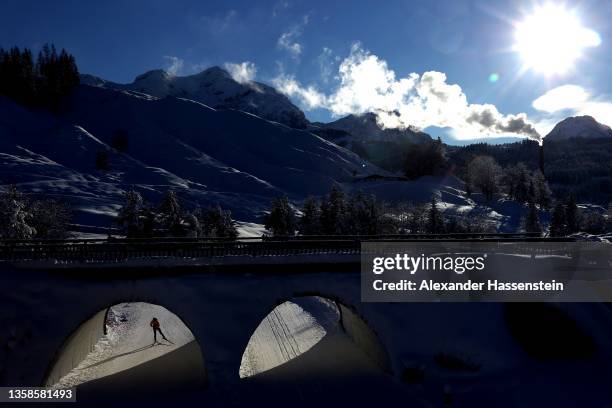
116,189,238,239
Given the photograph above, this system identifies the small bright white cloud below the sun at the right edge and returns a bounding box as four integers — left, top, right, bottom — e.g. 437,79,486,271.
532,85,612,130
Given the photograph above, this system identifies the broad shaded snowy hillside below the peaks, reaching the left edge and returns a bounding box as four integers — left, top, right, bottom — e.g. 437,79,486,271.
0,85,385,227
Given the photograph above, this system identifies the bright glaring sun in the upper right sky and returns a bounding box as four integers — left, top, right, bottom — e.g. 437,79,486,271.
514,4,601,75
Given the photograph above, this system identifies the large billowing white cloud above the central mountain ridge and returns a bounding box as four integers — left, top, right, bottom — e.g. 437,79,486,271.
274,44,540,140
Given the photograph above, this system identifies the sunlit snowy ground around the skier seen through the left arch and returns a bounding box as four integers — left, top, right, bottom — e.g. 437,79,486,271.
50,302,194,388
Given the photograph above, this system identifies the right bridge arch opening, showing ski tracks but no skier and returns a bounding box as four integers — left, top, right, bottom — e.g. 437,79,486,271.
239,296,390,381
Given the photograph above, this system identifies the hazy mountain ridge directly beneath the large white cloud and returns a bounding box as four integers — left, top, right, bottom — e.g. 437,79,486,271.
313,112,431,144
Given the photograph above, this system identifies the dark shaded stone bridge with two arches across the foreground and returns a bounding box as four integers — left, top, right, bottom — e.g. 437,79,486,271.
0,236,612,406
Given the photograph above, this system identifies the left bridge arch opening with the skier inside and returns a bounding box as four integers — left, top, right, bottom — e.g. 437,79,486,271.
44,302,206,393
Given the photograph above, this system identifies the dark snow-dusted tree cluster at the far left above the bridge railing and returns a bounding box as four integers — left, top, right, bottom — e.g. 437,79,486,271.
0,186,72,239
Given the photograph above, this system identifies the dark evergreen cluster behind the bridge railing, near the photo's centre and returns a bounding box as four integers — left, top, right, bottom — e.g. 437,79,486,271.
264,186,386,236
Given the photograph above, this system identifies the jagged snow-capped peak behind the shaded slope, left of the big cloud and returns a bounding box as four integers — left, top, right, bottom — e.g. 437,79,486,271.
81,67,308,129
